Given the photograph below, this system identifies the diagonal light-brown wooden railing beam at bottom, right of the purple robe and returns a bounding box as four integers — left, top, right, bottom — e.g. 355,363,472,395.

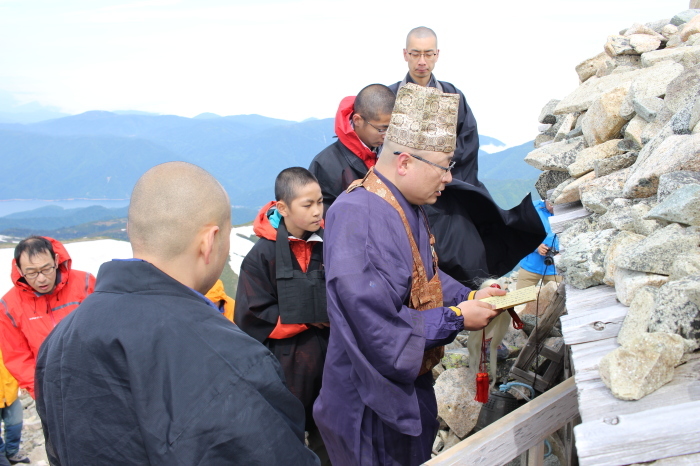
425,378,578,466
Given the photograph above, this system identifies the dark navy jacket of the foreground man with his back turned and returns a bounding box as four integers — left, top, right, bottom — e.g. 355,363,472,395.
36,261,318,466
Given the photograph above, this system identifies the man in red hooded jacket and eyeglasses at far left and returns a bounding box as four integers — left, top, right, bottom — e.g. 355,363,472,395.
0,236,95,397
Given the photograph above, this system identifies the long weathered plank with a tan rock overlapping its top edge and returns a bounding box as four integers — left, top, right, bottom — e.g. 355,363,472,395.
576,354,700,424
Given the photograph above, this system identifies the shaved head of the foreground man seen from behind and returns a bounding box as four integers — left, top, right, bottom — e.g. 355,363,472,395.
128,162,231,260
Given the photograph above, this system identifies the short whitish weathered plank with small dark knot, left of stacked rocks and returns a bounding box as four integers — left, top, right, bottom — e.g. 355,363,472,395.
561,303,629,345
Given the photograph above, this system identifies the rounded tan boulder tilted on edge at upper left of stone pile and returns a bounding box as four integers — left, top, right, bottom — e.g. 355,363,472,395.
582,87,629,147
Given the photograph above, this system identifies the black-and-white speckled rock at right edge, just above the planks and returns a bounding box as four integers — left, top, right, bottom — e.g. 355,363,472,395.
649,275,700,347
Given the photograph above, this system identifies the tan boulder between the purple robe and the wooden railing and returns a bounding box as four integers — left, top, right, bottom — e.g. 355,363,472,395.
435,367,481,437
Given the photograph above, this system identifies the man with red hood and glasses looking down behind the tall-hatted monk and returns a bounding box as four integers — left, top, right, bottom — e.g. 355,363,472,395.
309,84,396,215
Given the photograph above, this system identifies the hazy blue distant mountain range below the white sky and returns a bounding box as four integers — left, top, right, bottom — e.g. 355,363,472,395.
0,111,539,232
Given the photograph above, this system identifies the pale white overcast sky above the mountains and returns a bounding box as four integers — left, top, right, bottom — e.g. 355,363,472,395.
0,0,689,145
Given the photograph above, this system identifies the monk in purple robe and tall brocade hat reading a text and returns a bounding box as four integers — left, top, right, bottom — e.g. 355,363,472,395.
314,84,505,466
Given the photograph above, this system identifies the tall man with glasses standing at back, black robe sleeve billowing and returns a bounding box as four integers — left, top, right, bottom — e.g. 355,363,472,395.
389,27,546,286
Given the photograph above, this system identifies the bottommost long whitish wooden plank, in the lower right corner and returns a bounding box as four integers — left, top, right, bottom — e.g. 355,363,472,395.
574,401,700,466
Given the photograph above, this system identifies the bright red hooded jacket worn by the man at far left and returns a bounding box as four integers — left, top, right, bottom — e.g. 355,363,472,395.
0,237,95,397
